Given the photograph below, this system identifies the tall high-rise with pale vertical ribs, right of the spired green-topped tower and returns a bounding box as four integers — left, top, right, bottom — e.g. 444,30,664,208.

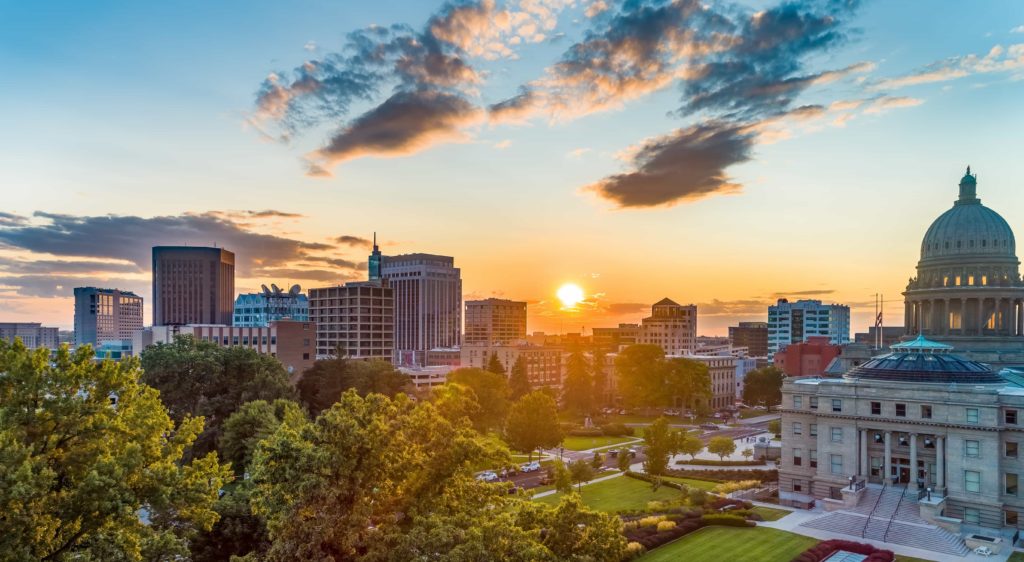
382,254,462,365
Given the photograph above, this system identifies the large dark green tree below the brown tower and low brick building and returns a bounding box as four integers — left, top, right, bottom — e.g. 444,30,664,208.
140,336,295,455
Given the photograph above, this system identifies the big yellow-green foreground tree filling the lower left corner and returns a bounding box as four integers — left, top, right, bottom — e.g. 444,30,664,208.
0,341,231,561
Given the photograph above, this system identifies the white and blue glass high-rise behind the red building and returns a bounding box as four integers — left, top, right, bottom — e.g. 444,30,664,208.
768,299,850,357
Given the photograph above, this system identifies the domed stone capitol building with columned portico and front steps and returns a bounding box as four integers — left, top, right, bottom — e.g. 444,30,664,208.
779,168,1024,560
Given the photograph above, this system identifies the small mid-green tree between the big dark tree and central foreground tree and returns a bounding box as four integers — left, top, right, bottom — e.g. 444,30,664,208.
218,398,306,476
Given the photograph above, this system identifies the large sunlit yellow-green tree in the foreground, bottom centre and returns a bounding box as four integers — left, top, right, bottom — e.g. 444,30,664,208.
252,390,625,562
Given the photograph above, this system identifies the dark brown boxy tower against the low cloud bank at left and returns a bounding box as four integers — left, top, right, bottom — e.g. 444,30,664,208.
153,246,234,326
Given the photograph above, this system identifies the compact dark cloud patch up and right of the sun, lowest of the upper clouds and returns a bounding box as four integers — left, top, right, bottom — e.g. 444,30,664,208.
586,122,755,208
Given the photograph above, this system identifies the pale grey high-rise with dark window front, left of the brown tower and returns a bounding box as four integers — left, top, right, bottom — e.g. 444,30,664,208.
75,287,142,347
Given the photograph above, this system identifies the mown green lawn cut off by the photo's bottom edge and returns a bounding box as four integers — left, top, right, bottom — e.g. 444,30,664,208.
639,527,818,562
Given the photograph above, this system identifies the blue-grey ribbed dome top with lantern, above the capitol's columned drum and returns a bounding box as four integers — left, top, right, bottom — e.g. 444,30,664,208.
921,167,1017,262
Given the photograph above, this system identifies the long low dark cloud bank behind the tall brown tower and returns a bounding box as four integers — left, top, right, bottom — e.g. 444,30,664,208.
0,212,334,276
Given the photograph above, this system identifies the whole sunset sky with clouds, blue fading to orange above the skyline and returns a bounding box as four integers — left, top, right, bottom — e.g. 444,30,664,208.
0,0,1024,335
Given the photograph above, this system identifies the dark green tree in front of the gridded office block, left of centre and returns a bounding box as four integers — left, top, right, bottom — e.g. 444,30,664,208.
296,356,409,417
